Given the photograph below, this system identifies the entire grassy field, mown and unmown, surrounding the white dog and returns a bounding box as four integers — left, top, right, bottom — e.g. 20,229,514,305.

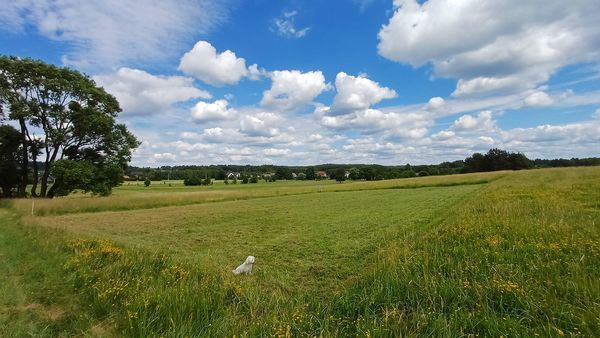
0,168,600,337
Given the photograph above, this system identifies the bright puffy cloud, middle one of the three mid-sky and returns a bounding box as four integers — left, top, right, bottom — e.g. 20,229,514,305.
260,70,330,111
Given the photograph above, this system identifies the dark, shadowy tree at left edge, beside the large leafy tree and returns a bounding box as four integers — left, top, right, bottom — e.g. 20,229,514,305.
0,125,21,198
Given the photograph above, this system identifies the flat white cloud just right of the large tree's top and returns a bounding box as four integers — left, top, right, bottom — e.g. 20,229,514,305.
93,68,211,115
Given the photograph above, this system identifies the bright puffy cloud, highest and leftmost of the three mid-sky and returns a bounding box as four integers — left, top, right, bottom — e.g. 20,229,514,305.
179,41,264,86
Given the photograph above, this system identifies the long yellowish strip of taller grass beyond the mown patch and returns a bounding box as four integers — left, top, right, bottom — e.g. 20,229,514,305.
14,172,506,216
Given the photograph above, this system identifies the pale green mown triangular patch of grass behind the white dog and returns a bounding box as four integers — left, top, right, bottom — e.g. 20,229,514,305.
35,185,480,297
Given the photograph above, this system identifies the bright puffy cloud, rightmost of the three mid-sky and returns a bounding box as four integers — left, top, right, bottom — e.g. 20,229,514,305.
330,72,396,114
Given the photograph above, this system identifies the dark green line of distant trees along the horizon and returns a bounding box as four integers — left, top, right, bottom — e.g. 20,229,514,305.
125,149,600,183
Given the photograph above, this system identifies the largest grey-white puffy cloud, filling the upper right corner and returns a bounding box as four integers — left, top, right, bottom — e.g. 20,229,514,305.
378,0,600,96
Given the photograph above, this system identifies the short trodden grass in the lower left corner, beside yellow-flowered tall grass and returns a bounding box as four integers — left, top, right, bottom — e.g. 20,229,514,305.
0,205,112,337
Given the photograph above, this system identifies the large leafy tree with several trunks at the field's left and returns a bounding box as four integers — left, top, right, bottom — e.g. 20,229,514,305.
0,56,139,197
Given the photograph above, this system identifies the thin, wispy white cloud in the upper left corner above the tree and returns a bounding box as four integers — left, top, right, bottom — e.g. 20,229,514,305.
0,0,227,69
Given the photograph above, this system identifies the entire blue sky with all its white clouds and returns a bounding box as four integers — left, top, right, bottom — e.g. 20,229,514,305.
0,0,600,167
